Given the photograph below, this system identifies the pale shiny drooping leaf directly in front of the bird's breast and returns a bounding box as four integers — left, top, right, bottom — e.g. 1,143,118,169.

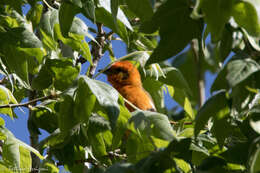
80,76,119,129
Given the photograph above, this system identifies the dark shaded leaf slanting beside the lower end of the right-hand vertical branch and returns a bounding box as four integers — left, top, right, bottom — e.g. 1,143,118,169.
194,90,228,136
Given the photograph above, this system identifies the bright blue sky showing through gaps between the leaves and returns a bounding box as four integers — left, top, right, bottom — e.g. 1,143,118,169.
0,3,215,144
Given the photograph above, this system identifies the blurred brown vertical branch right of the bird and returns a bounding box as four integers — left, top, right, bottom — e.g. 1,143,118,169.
191,39,206,107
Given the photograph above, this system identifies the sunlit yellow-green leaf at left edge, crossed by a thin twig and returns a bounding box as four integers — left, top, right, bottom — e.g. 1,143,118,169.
0,85,17,118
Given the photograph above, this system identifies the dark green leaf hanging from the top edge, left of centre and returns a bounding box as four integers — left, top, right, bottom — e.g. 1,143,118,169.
59,2,80,37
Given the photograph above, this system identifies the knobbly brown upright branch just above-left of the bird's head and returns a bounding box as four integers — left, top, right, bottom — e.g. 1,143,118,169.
88,23,106,78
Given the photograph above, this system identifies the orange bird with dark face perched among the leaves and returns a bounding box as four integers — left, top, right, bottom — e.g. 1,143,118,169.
104,61,156,112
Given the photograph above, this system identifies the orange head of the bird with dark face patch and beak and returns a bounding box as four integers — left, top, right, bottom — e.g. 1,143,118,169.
103,61,142,88
